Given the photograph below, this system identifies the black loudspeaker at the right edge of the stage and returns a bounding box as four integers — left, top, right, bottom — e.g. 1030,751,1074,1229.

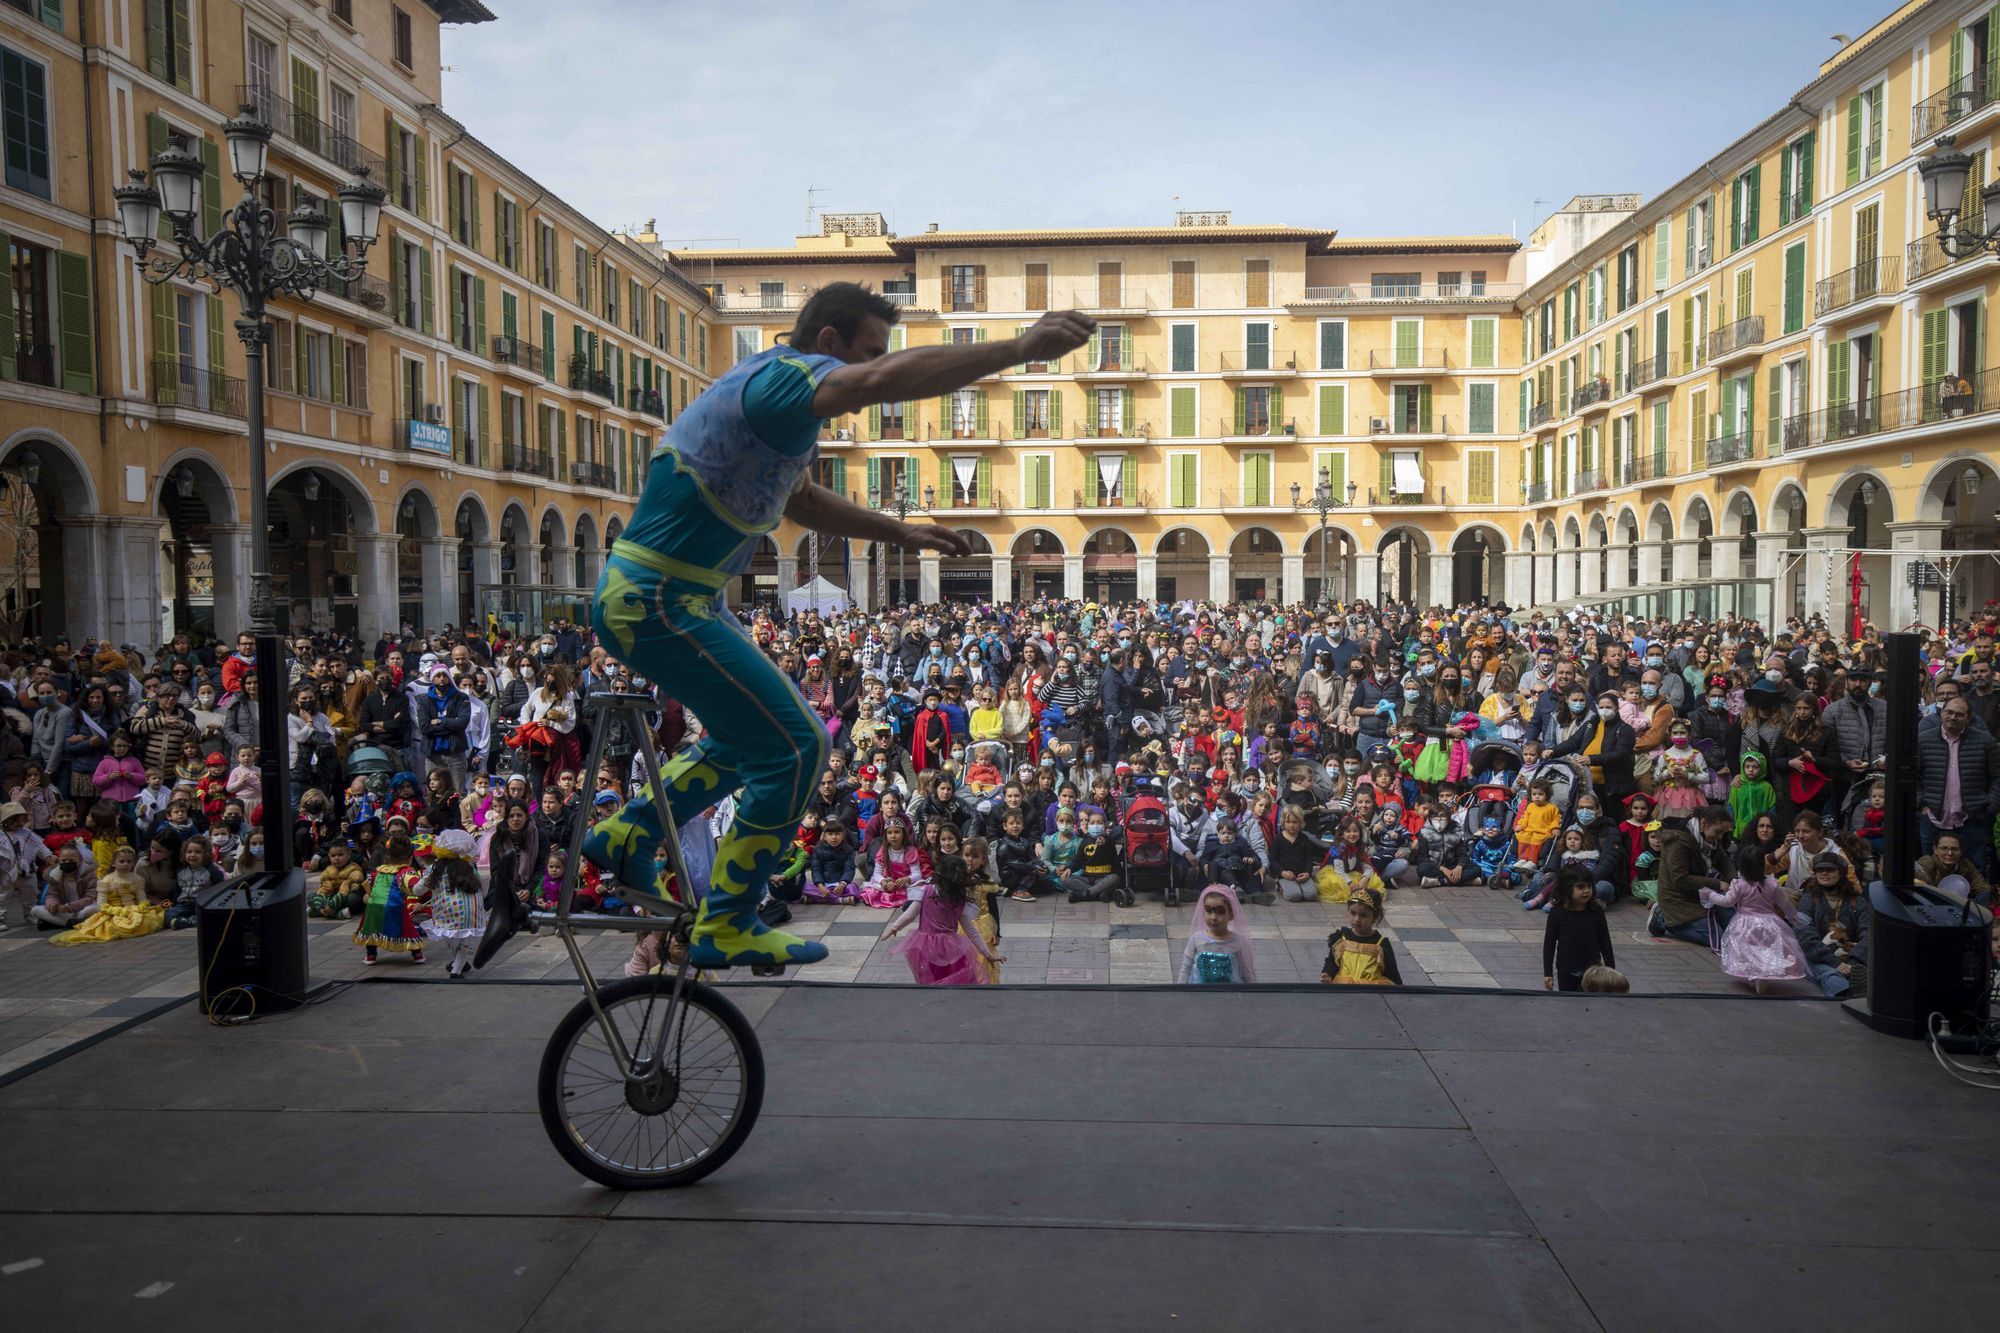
1848,881,1992,1037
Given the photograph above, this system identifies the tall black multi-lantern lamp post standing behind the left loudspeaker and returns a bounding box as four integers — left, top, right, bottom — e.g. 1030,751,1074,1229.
112,106,388,871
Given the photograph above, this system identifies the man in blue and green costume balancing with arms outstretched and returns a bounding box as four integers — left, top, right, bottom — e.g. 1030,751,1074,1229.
482,282,1096,969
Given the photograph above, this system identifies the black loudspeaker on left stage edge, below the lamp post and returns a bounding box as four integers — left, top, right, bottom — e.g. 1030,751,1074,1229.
194,871,306,1019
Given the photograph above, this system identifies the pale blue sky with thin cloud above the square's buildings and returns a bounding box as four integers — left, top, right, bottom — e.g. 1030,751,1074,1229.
444,0,1892,246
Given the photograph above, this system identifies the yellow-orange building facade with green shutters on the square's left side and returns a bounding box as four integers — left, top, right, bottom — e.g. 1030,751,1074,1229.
0,0,710,644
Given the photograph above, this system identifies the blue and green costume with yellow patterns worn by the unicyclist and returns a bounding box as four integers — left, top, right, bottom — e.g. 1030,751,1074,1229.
584,346,842,967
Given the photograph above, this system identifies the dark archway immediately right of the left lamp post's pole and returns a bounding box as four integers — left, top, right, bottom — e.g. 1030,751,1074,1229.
268,462,374,636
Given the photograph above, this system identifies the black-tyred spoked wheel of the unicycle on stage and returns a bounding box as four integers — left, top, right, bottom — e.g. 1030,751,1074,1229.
538,975,764,1189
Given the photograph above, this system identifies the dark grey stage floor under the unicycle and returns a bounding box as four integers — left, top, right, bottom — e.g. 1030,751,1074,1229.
0,979,2000,1333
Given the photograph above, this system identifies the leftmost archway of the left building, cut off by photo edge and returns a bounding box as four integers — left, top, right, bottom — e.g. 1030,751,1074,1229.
0,430,102,642
